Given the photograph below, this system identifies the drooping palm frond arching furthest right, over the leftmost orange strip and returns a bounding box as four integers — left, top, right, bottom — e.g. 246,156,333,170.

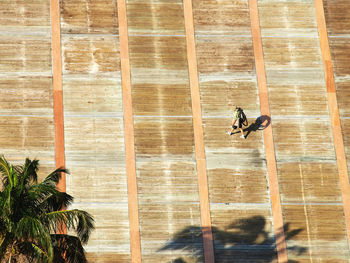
42,209,95,244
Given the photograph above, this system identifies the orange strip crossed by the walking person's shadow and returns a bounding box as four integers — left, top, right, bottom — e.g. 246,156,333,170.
249,0,288,262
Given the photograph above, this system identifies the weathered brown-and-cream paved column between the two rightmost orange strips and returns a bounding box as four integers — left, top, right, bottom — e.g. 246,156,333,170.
259,0,349,262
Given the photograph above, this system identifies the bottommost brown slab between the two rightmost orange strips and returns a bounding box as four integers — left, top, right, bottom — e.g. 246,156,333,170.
284,205,349,262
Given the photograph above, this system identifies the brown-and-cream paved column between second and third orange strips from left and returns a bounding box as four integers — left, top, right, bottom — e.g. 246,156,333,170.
127,1,202,263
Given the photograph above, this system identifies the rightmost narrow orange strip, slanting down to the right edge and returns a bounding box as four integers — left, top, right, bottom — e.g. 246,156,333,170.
314,0,350,248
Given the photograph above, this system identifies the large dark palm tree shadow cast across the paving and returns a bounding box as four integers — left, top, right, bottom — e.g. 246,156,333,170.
159,216,307,263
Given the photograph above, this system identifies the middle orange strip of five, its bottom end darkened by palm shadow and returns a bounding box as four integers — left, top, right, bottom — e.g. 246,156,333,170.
183,0,214,263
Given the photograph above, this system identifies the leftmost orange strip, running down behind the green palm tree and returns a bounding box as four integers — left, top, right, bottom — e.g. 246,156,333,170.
50,0,66,192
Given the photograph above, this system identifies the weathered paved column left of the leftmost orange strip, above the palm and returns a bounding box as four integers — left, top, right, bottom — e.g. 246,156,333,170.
0,0,55,182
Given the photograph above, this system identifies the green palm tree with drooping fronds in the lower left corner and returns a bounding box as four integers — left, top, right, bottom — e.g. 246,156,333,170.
0,156,94,263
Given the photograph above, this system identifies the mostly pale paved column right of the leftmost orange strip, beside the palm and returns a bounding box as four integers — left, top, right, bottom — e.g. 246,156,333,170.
61,0,131,262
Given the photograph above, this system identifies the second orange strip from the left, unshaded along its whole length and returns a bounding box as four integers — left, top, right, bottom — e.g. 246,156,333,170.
117,0,141,263
